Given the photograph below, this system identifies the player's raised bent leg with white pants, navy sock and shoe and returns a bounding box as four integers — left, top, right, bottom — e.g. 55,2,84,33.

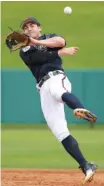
50,74,97,123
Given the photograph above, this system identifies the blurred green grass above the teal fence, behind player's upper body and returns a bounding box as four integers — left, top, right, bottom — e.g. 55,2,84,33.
1,1,104,69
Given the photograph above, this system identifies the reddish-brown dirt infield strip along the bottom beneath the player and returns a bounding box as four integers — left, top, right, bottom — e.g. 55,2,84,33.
1,169,104,186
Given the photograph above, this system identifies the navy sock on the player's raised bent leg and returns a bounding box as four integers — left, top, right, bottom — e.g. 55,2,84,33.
62,92,84,109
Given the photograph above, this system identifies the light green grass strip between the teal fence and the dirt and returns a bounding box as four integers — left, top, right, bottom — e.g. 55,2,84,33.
2,124,104,168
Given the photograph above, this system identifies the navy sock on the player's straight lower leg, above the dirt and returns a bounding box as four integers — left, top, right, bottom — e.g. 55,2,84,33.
62,135,87,167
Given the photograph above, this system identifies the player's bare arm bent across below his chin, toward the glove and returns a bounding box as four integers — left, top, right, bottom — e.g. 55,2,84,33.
29,36,66,48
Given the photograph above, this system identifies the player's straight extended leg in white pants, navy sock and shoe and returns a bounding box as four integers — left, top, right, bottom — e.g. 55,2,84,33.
40,77,95,181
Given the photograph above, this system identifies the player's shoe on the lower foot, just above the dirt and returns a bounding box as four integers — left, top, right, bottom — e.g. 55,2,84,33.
79,162,97,184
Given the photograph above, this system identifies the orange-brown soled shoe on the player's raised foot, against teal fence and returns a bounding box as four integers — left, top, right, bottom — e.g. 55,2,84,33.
73,108,97,123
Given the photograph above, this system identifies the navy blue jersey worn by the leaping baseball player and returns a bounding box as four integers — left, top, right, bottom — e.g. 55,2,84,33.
20,34,64,83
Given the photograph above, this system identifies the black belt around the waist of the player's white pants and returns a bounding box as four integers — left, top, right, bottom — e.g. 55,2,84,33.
38,70,64,87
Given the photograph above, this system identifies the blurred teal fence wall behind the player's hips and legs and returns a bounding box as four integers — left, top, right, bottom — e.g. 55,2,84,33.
1,69,104,124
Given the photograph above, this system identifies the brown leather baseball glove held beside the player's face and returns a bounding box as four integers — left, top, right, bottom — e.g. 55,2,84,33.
6,31,30,51
